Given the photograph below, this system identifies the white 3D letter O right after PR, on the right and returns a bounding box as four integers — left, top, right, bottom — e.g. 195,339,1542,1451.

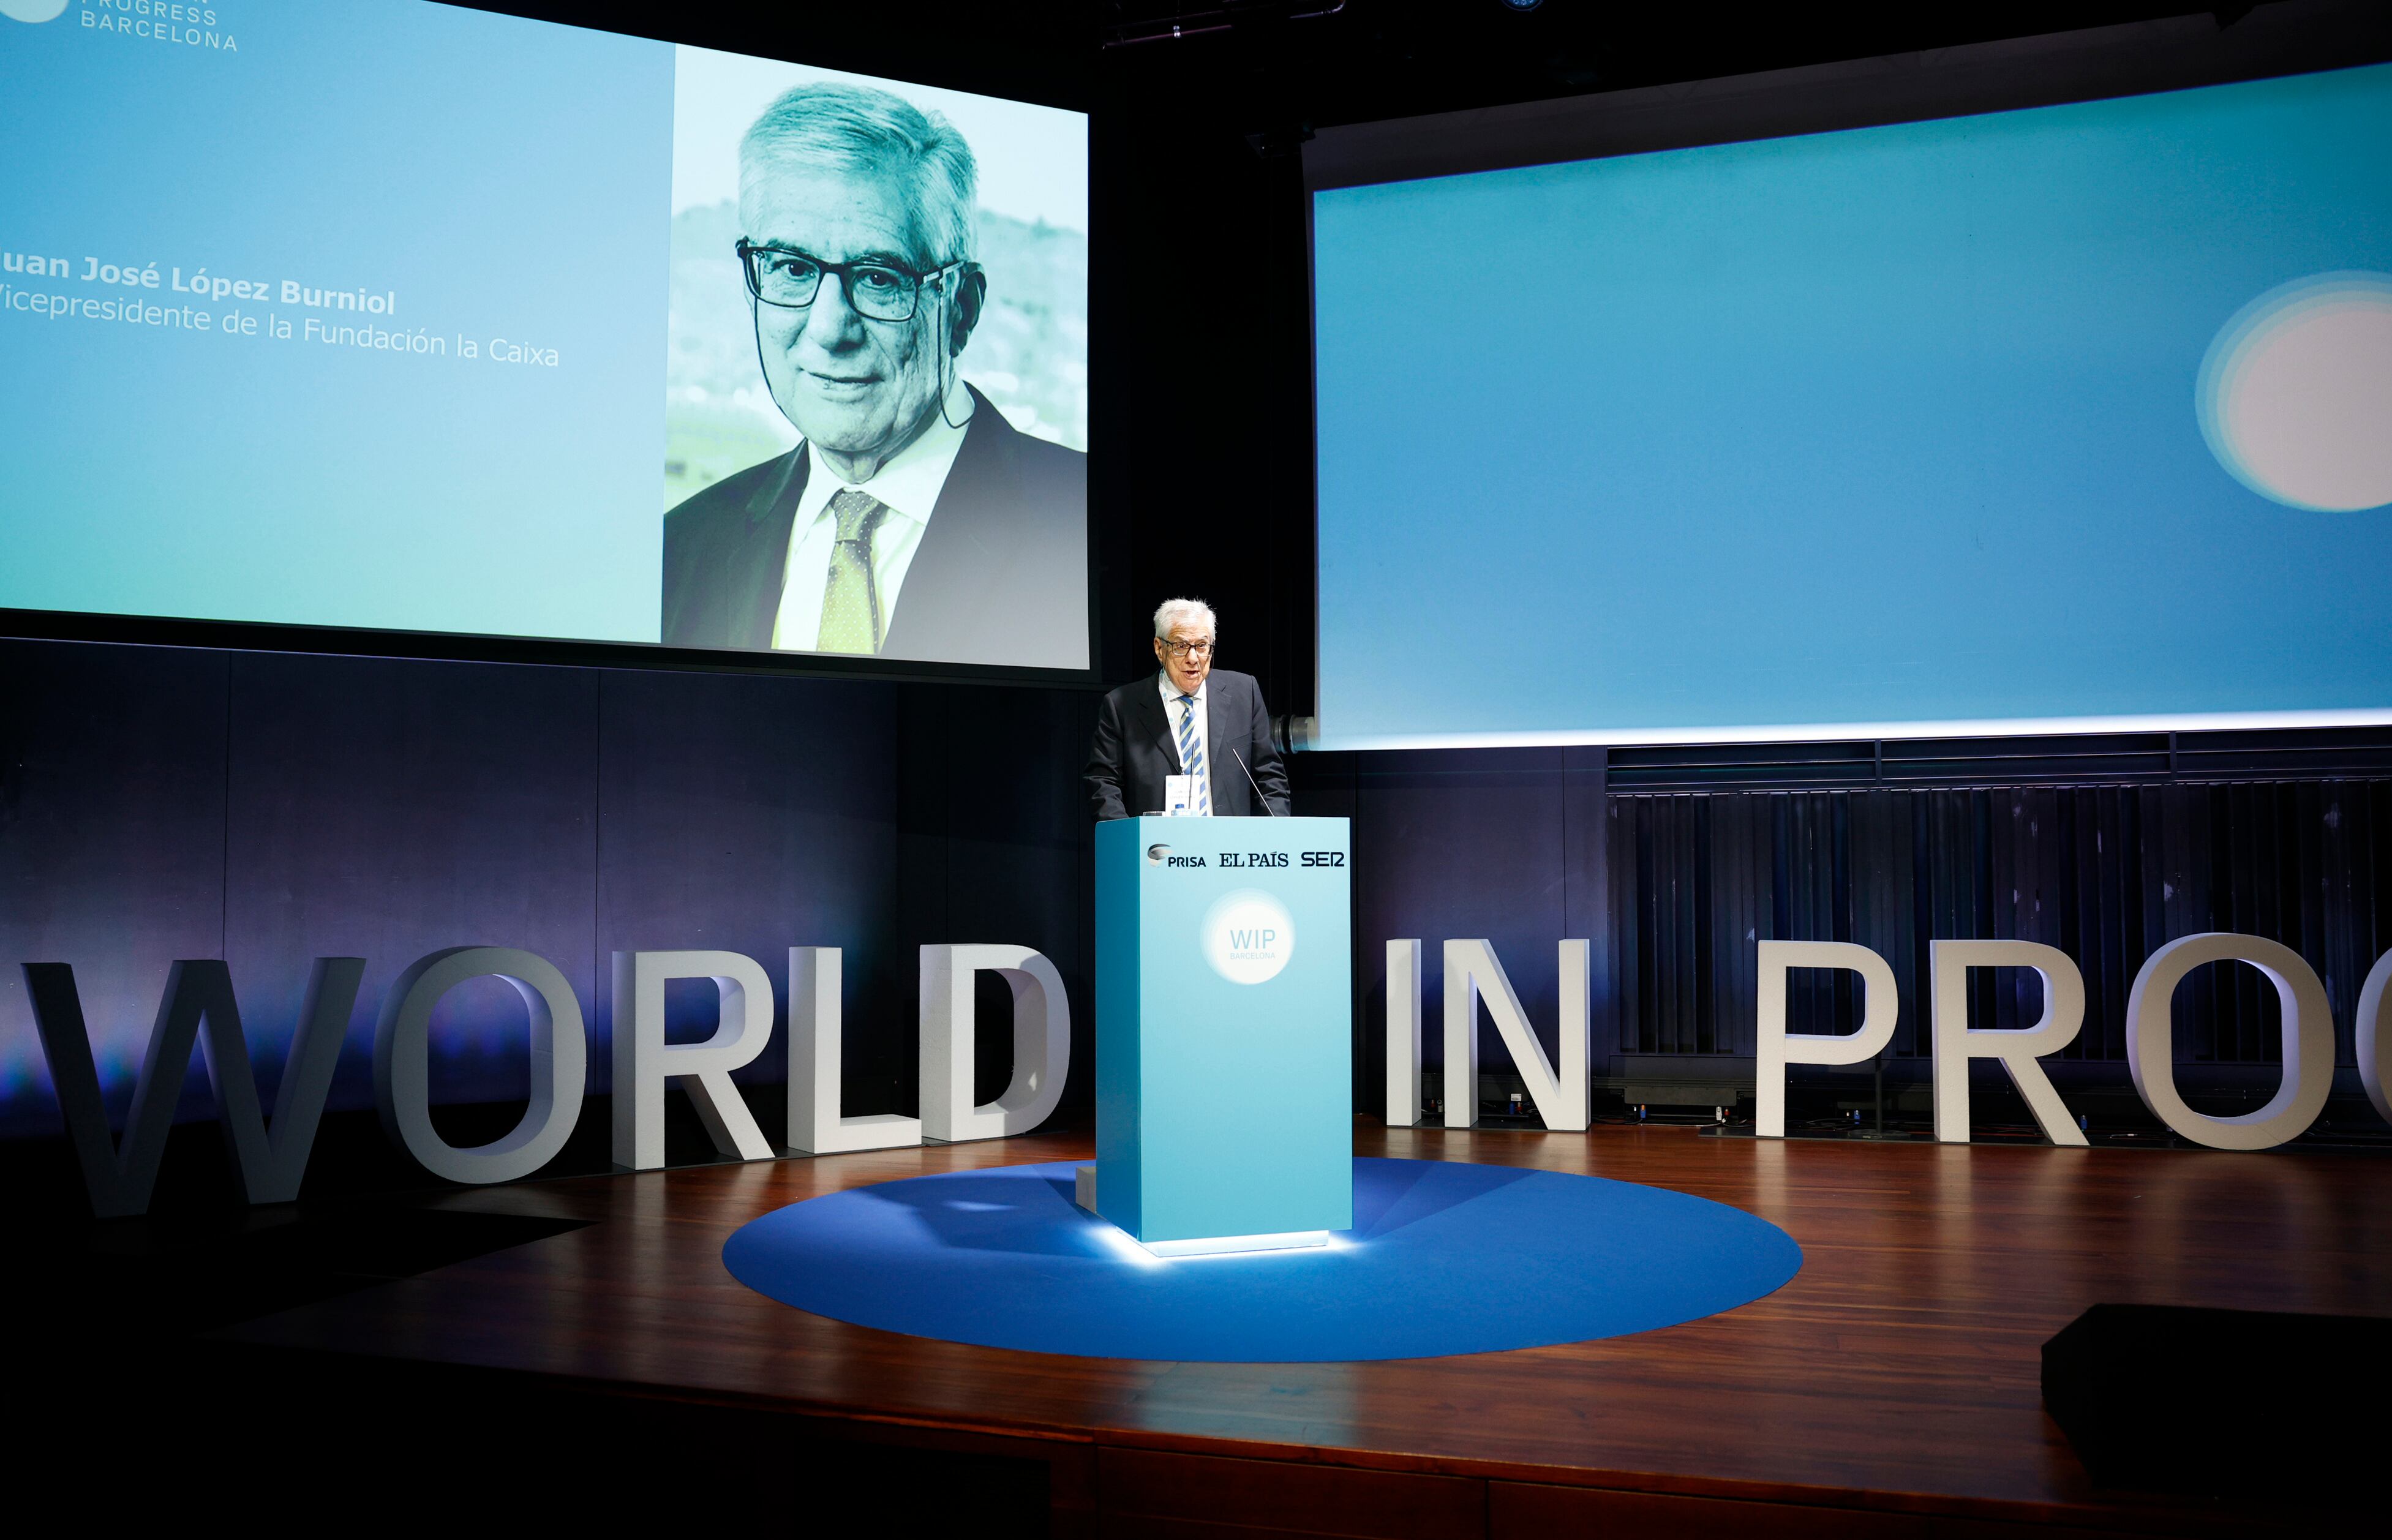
2126,930,2334,1150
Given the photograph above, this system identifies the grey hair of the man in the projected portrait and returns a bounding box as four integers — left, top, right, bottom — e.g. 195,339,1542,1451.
739,81,980,268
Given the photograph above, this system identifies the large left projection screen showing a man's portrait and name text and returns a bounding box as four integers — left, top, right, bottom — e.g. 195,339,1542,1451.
0,0,1091,677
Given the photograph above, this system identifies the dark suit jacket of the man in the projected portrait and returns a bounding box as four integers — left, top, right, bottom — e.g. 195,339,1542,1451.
663,390,1088,669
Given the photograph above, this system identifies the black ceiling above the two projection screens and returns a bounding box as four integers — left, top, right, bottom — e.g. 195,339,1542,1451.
457,0,2251,137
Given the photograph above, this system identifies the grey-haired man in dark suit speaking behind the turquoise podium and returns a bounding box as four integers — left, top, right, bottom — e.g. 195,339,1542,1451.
1083,598,1292,821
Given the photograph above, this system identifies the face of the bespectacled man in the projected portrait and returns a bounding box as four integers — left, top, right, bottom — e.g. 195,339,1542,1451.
742,167,979,478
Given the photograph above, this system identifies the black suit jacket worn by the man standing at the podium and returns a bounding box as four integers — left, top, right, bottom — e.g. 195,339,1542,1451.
1086,669,1292,818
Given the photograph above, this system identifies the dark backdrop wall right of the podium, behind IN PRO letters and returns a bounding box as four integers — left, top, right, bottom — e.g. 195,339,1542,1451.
1296,729,2392,1117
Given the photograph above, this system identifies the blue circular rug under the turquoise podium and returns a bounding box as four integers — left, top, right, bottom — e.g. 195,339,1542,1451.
723,1160,1801,1363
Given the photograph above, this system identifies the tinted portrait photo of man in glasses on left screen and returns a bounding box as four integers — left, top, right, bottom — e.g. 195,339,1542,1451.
660,48,1088,669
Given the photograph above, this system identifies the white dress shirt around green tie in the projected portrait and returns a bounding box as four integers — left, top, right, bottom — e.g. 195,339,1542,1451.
773,383,974,653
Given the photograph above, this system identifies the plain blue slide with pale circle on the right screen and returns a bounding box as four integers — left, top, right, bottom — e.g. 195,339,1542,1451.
1313,67,2392,748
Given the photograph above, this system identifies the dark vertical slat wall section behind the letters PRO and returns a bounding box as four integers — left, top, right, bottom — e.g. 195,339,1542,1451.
1608,779,2392,1064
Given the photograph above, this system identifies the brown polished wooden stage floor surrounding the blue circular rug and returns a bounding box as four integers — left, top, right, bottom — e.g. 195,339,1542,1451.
215,1124,2392,1538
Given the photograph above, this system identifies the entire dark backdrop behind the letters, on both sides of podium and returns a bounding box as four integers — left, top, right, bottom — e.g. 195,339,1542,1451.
0,641,2392,1166
